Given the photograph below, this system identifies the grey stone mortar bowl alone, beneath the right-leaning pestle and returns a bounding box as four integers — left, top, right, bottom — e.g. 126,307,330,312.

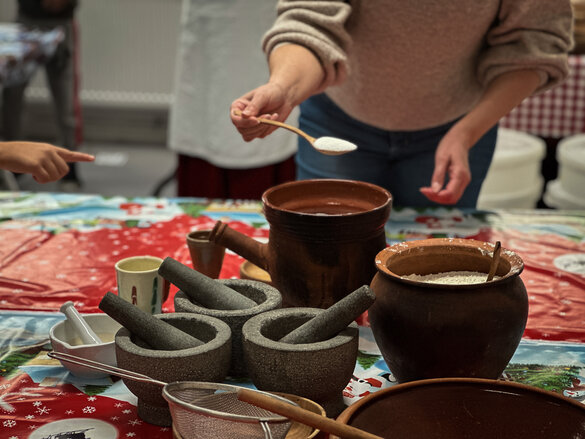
242,308,359,417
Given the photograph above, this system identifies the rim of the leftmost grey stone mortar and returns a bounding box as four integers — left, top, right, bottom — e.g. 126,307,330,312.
115,312,232,359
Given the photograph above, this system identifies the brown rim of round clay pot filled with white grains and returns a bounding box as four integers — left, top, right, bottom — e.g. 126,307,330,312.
375,238,524,290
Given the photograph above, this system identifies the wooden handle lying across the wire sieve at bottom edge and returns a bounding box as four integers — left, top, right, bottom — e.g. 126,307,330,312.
238,389,383,439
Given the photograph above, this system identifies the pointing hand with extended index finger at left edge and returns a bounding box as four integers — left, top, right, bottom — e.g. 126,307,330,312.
0,142,95,183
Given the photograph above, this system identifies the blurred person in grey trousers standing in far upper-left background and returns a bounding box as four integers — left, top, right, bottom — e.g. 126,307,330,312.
2,0,82,191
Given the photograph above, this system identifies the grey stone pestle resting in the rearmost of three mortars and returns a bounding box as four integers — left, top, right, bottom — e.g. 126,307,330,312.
158,257,258,310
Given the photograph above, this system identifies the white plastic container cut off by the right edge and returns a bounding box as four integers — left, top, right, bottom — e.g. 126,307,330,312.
543,134,585,209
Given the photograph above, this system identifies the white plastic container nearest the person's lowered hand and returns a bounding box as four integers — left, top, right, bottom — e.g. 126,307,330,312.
477,128,546,209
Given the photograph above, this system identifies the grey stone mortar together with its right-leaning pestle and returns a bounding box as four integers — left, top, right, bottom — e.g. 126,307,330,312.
242,286,375,416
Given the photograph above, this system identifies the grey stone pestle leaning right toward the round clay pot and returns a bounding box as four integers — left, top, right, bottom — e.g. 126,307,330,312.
279,285,376,344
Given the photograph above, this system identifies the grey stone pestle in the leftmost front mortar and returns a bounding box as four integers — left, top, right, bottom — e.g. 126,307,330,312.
99,292,204,351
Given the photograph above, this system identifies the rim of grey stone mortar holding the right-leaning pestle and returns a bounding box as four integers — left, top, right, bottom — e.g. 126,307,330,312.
242,307,359,354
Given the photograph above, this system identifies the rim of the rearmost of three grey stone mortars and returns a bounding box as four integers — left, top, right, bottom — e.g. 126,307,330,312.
175,279,282,318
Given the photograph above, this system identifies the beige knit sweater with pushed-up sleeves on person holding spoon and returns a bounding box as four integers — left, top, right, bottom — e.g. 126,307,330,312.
262,0,572,130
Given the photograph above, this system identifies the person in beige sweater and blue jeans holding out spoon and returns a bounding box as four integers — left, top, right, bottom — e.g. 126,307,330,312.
230,0,572,207
